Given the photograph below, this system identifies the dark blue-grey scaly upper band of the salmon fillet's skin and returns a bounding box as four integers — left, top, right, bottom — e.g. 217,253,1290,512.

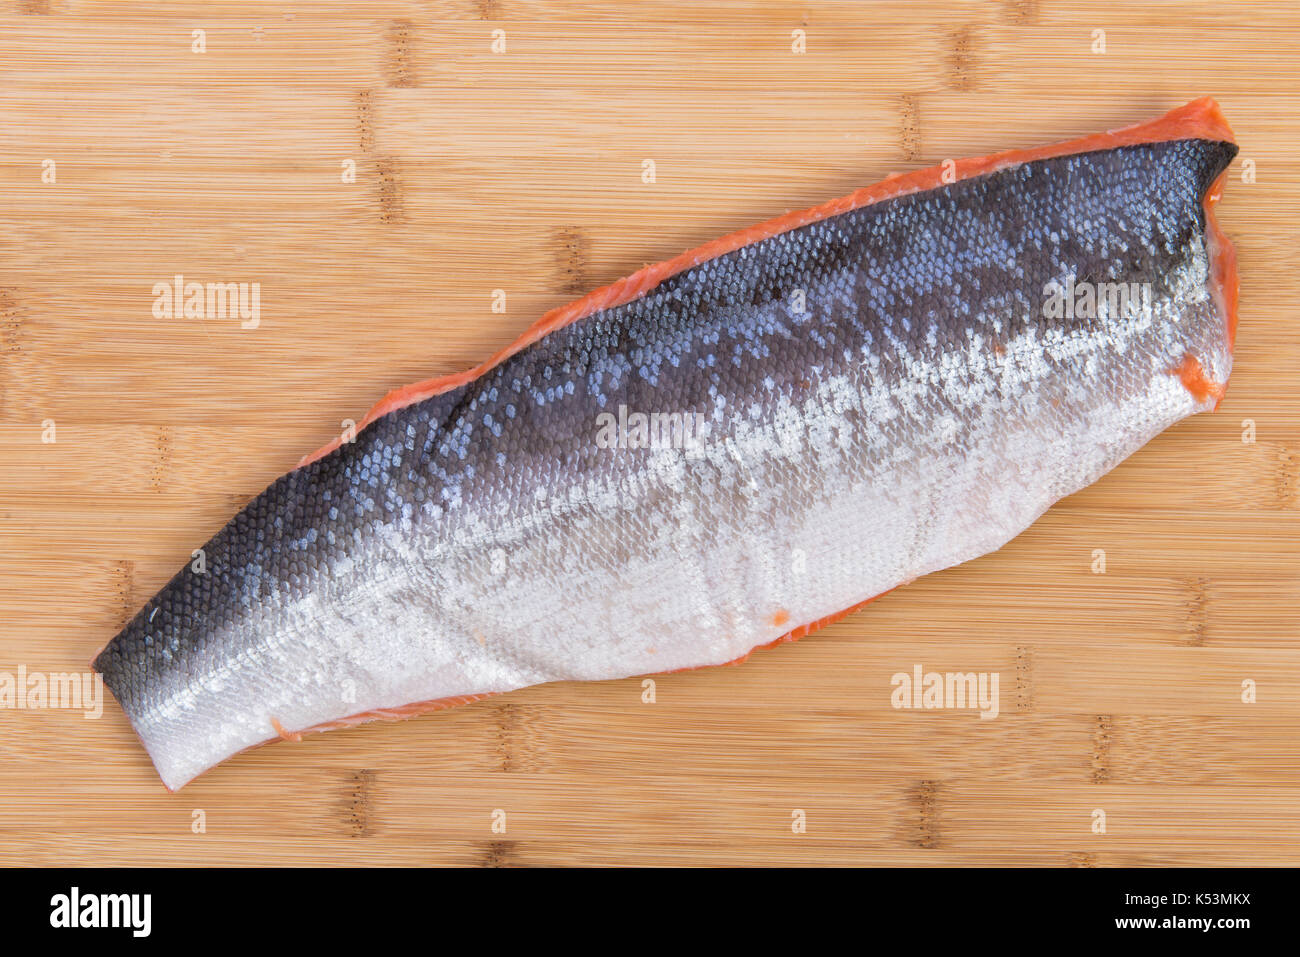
95,139,1236,719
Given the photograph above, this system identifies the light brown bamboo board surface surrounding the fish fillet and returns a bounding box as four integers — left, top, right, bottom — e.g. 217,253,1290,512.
0,0,1300,866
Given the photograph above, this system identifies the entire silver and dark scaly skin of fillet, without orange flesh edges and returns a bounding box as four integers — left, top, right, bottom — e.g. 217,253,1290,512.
95,108,1236,789
